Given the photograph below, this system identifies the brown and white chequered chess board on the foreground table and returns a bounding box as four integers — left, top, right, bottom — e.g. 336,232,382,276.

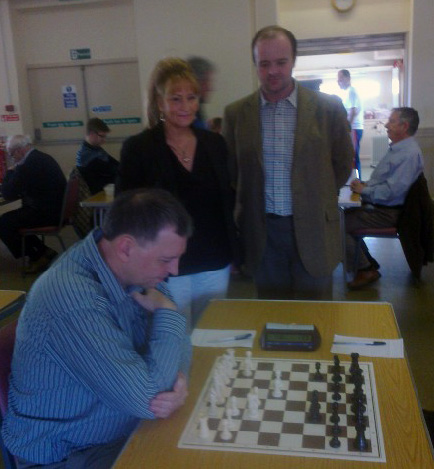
178,357,386,462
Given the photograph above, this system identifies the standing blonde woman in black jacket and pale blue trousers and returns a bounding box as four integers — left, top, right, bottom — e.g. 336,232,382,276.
116,58,236,330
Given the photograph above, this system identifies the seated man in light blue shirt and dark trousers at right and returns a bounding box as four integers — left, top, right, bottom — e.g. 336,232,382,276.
345,107,423,289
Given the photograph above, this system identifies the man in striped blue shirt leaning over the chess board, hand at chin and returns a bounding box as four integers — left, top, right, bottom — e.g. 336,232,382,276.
2,189,192,469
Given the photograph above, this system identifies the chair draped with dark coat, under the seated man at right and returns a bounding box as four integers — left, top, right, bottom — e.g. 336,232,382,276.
351,173,434,279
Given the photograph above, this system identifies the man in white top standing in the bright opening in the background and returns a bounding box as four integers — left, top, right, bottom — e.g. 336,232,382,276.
338,69,364,179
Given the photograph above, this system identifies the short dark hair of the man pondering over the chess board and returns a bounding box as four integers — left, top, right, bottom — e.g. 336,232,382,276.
102,189,193,244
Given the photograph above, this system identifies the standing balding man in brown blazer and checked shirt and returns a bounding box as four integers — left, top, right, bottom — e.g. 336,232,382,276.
223,26,354,299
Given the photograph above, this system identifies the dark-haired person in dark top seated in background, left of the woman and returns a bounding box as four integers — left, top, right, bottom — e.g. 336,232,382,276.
77,117,119,195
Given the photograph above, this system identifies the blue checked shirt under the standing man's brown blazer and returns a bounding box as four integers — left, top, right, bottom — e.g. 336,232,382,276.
260,82,298,216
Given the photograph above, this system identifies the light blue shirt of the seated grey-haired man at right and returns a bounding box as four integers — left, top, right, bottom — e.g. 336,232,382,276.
362,137,423,206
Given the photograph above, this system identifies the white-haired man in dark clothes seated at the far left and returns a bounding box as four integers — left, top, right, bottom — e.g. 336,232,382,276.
0,135,66,273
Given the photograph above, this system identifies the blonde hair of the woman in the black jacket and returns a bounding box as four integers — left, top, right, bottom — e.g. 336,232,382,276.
147,57,199,127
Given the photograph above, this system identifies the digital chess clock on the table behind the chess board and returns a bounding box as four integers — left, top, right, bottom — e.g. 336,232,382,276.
261,322,321,352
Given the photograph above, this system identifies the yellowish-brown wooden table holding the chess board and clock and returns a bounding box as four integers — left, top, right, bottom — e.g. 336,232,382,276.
115,300,434,469
